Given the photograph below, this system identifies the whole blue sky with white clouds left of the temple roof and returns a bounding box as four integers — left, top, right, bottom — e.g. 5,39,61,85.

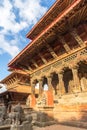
0,0,56,80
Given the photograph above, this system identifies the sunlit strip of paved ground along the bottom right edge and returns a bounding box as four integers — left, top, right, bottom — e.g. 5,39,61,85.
33,125,87,130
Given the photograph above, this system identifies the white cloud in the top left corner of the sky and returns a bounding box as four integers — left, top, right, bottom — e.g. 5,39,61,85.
0,0,27,33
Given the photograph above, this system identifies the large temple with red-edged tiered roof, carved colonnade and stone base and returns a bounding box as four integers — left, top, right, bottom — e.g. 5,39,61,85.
0,0,87,125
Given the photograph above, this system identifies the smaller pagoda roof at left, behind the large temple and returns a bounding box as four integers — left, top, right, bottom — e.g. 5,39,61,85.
1,71,31,94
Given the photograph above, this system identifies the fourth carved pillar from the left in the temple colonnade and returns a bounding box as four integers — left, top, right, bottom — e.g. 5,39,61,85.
58,72,65,94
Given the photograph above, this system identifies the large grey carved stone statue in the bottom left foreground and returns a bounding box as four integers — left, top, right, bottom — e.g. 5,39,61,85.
9,103,32,130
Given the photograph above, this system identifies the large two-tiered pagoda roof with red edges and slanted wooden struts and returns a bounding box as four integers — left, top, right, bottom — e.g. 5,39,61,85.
8,0,87,73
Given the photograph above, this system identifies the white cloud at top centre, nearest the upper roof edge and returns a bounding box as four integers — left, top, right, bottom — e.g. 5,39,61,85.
14,0,47,25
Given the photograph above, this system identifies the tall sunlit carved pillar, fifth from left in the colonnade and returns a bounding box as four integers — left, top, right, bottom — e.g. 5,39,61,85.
72,66,81,92
